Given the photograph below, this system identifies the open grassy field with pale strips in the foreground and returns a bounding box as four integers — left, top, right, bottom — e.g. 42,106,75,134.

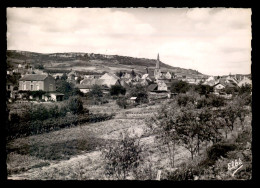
7,101,251,180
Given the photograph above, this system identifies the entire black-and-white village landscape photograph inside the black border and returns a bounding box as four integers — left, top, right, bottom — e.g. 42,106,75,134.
5,7,252,181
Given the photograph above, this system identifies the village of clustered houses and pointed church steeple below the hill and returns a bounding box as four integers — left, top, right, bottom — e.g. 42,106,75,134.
6,54,252,102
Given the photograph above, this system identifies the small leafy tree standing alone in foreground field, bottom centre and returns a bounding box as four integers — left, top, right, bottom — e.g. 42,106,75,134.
102,133,142,180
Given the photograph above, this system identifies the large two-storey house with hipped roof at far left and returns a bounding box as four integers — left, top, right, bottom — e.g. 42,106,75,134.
19,74,56,91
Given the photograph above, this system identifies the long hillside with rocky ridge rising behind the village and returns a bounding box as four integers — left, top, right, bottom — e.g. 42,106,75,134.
6,50,205,75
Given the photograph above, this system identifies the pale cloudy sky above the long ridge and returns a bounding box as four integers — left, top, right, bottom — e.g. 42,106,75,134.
6,8,252,76
